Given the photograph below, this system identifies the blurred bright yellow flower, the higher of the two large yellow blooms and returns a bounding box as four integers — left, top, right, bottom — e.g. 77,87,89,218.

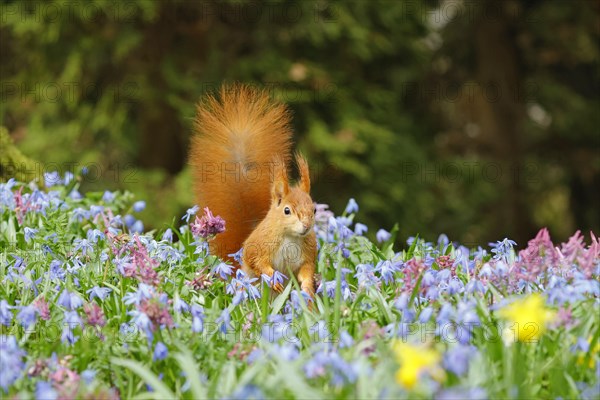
498,293,554,342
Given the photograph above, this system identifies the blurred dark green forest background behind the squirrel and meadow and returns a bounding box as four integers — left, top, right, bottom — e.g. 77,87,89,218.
0,0,600,246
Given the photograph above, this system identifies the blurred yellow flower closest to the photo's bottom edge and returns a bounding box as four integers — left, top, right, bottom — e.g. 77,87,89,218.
393,342,444,389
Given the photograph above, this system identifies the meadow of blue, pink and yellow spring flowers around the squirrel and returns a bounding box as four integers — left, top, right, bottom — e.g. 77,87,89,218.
0,174,600,399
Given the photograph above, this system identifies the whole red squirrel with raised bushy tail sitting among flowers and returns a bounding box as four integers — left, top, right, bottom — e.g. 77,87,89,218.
190,85,317,296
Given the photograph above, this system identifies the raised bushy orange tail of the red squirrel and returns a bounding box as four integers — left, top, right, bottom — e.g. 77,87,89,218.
190,85,292,258
